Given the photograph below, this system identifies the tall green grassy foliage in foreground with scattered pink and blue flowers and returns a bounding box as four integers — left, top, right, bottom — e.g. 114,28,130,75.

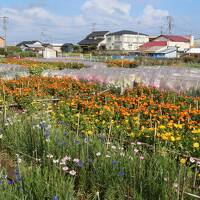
0,110,199,200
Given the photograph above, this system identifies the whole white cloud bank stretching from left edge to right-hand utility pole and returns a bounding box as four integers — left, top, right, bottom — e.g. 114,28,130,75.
0,0,169,42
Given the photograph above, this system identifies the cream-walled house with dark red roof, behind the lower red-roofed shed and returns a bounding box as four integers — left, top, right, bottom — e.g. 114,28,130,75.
152,35,194,52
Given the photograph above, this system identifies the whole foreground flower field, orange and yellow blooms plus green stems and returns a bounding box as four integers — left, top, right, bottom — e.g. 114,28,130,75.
0,63,200,200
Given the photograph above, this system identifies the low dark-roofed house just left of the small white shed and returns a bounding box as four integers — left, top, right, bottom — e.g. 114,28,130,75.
17,40,44,54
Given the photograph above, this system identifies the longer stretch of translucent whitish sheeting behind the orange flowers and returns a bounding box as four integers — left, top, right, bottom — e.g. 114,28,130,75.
42,63,200,92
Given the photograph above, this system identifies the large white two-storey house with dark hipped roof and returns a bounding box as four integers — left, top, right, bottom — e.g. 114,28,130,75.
106,30,149,51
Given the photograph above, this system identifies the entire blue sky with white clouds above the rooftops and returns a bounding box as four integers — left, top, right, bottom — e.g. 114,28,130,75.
0,0,200,44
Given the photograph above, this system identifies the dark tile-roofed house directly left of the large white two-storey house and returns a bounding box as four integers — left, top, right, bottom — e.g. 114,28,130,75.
78,31,109,50
